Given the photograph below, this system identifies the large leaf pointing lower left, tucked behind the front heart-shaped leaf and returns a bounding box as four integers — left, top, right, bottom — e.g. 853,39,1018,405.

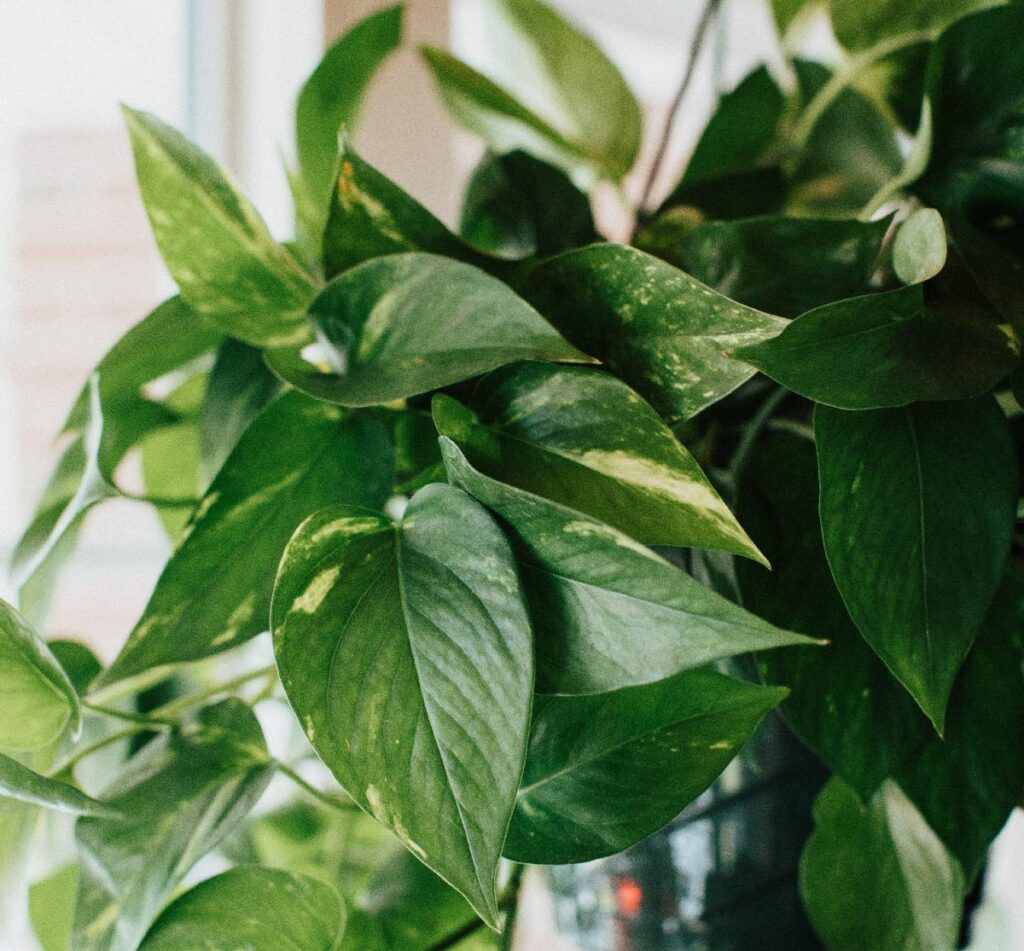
102,393,392,683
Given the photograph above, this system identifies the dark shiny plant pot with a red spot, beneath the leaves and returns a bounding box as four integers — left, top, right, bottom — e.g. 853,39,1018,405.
549,717,825,951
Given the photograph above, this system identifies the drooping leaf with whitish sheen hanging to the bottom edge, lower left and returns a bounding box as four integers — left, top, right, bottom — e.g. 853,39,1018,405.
72,699,273,951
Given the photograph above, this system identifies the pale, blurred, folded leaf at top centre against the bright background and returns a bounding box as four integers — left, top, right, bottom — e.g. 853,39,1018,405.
423,0,641,180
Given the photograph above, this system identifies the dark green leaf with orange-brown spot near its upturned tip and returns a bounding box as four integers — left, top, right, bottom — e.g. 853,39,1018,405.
324,139,493,277
